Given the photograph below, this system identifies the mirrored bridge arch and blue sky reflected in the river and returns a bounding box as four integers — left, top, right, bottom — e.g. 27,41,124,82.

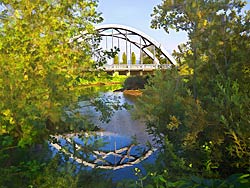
51,132,153,170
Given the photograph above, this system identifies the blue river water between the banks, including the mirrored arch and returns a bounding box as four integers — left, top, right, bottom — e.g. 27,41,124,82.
49,89,156,181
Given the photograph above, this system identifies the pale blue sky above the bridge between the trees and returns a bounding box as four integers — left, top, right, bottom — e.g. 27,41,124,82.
97,0,250,53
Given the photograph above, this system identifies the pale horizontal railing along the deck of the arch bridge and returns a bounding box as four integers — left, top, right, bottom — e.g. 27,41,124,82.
104,64,171,71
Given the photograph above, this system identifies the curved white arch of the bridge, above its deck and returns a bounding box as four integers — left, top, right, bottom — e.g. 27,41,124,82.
95,24,177,65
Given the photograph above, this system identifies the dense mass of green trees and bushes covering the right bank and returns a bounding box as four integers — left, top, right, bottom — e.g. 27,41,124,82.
135,0,250,181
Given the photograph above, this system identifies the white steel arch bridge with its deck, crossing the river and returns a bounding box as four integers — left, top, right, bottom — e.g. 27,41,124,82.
75,24,177,72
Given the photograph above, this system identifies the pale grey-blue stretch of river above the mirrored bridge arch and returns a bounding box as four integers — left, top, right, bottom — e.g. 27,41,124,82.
79,92,152,144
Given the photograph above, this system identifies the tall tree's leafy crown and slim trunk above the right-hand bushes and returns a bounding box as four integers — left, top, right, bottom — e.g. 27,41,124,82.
152,0,249,98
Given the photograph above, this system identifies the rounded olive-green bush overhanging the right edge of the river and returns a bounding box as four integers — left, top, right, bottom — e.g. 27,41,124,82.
135,69,206,178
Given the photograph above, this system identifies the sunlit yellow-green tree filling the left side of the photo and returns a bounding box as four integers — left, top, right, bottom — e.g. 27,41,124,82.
0,0,102,187
